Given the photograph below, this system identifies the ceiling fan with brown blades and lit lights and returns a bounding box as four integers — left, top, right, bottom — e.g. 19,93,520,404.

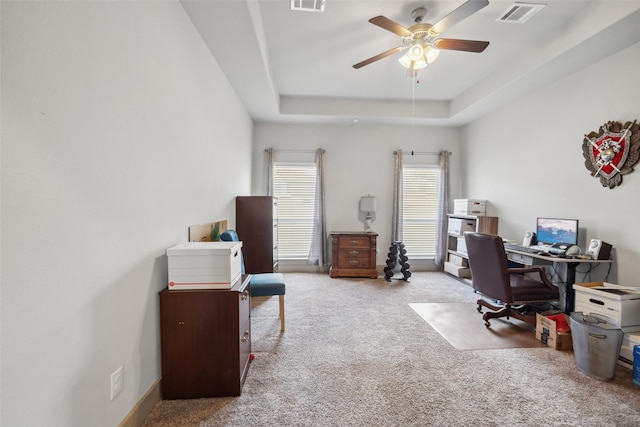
353,0,489,73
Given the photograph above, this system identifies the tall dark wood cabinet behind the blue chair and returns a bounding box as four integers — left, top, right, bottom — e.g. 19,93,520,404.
236,196,278,273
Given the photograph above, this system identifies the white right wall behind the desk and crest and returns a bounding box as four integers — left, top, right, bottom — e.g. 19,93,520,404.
461,44,640,286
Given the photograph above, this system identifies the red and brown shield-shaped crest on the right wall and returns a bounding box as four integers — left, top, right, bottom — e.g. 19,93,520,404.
582,120,640,188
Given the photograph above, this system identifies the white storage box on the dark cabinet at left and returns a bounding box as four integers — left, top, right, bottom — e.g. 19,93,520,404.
167,242,242,290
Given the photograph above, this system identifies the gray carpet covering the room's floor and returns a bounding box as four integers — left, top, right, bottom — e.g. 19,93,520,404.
144,273,640,427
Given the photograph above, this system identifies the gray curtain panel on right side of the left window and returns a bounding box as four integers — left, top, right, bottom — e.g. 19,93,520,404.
307,148,329,267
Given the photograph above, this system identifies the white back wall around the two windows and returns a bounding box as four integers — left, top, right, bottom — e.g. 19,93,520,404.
253,123,461,271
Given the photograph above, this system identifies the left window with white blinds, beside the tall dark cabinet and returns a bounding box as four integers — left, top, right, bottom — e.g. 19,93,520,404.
273,163,316,260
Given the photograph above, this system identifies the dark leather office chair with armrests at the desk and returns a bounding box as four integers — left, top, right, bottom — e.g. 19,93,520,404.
464,233,560,328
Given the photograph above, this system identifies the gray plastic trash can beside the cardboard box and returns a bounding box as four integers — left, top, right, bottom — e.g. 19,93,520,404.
571,312,624,381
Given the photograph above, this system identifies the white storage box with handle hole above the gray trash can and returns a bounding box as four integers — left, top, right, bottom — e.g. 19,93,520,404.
573,282,640,327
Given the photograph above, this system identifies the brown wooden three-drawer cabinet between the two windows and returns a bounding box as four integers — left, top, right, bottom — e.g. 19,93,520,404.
329,231,378,279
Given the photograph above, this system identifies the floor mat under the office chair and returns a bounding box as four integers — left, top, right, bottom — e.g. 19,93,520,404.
409,303,546,350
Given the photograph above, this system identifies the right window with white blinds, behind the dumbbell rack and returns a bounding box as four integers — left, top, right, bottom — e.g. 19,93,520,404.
402,165,440,259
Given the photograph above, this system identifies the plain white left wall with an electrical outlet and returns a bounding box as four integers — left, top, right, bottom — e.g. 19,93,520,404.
0,1,253,426
